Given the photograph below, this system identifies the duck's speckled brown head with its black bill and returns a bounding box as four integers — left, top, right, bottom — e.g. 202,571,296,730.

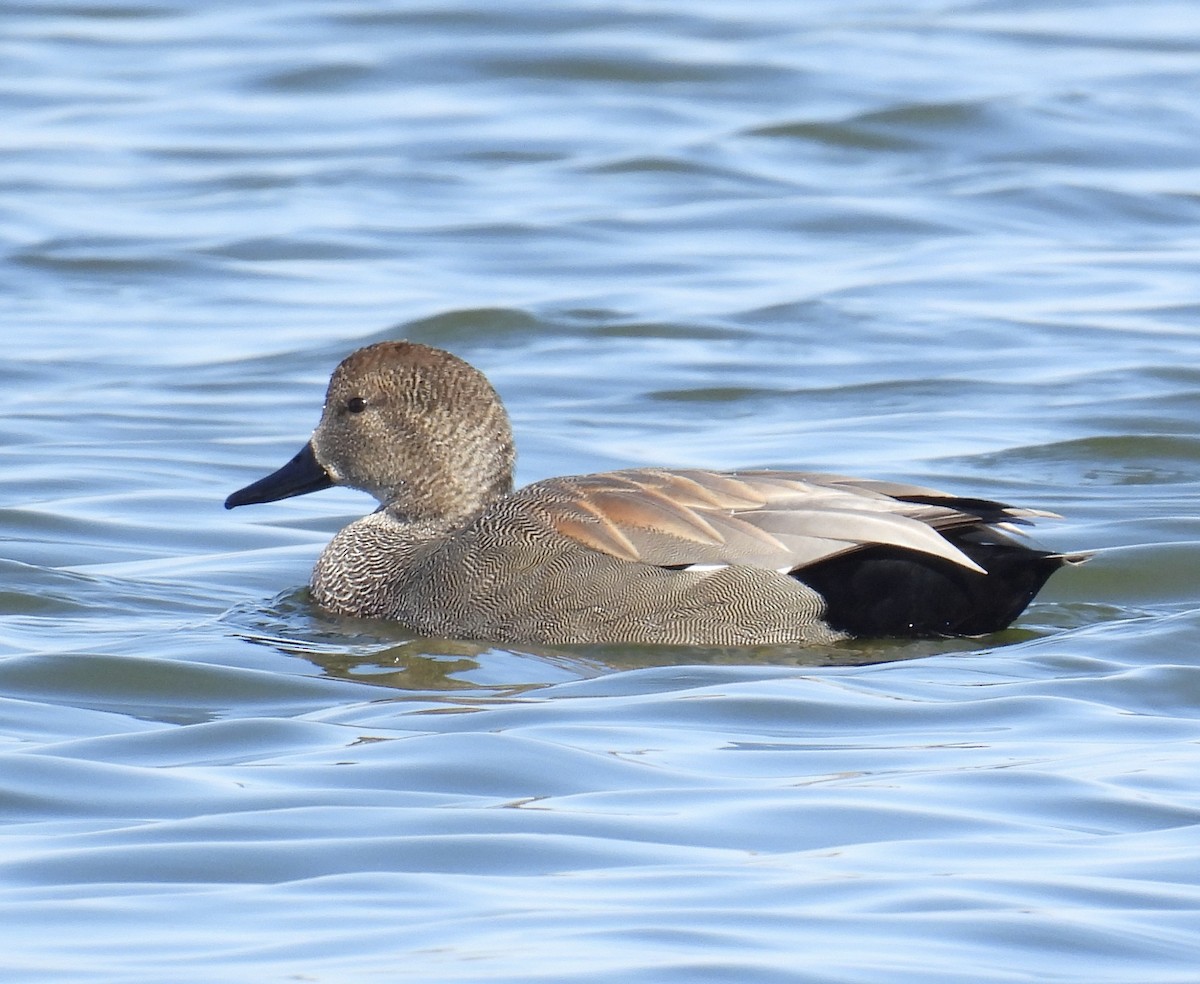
226,342,515,521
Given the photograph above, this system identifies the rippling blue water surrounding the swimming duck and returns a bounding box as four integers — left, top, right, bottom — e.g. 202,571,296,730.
0,0,1200,984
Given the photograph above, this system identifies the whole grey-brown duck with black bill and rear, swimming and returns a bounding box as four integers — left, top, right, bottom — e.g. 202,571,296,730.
224,341,1088,647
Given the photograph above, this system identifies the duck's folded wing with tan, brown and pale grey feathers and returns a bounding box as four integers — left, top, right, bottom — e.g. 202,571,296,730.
516,468,1052,572
